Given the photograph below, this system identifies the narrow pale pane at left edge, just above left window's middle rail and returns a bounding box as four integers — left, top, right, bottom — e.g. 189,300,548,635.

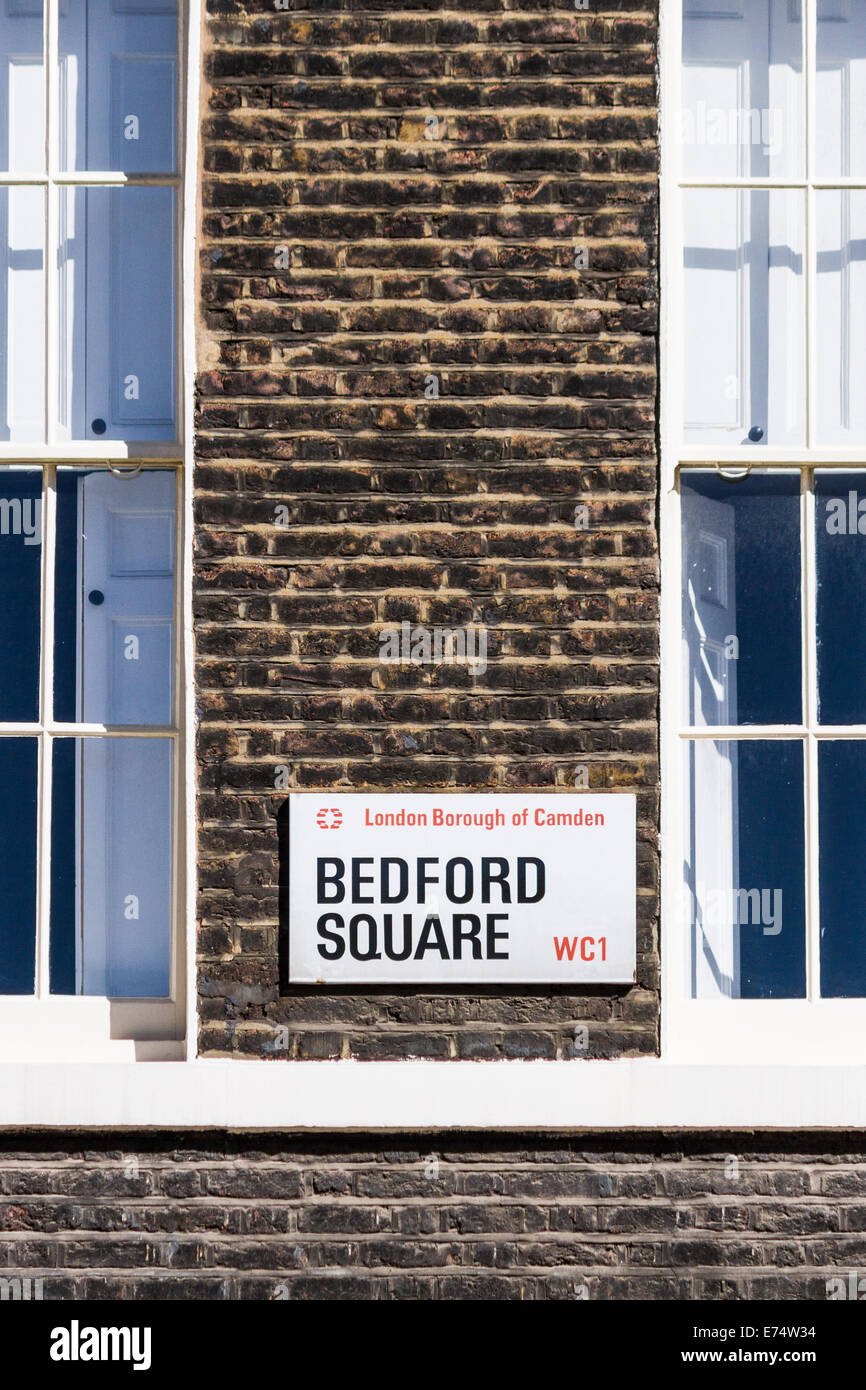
0,188,44,442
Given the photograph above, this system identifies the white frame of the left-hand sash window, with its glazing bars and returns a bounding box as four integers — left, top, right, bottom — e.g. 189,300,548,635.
0,0,202,1062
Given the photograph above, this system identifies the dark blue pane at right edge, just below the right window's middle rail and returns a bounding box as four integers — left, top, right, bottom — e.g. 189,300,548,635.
815,473,866,724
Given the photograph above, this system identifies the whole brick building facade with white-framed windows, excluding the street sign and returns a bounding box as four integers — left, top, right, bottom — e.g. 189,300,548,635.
0,0,866,1300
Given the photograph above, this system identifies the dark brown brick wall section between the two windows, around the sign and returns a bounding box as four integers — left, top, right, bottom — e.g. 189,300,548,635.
196,0,657,1058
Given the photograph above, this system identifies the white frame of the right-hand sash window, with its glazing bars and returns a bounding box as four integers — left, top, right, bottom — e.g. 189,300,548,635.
659,0,866,1063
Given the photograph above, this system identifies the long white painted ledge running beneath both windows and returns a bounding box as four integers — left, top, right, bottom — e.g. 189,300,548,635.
0,1059,866,1131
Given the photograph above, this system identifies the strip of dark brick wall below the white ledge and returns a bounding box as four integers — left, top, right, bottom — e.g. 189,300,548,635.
0,1133,866,1300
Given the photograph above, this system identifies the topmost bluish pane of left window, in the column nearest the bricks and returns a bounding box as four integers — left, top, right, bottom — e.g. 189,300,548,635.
60,0,178,174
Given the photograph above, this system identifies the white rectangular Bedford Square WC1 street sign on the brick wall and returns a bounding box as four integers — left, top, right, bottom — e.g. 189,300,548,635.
289,794,635,984
